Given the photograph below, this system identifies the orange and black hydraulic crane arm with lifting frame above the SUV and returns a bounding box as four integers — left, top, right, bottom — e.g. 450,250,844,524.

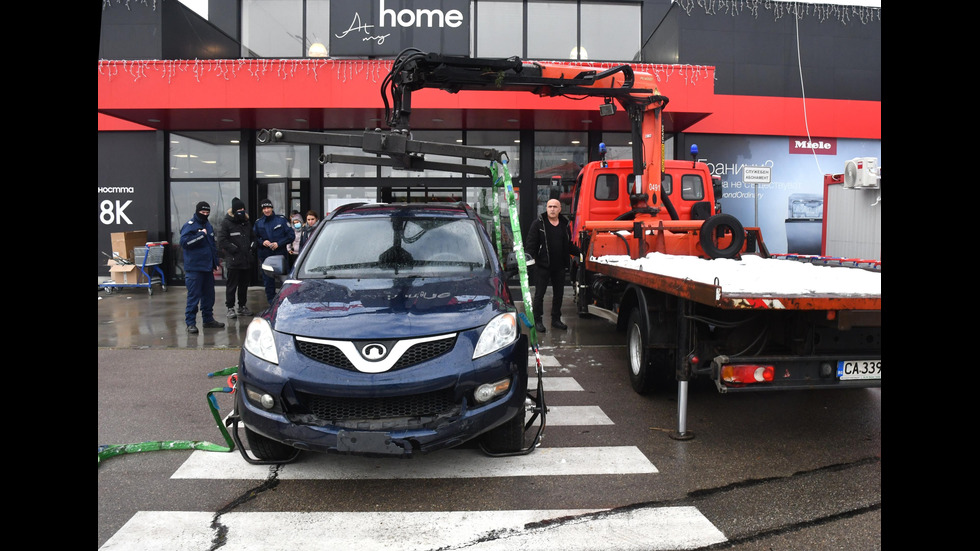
258,48,668,206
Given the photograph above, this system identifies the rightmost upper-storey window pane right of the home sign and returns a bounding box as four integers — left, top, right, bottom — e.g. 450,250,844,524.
571,2,640,61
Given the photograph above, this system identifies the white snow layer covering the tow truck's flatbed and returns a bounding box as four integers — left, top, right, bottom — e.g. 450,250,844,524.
591,253,881,297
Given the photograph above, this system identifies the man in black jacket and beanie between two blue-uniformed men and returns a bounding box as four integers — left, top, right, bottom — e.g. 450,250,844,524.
217,197,254,319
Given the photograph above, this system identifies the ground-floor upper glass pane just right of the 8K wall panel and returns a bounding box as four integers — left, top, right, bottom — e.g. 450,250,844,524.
170,132,239,178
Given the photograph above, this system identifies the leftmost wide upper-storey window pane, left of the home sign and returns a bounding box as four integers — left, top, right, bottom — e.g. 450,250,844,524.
242,0,306,57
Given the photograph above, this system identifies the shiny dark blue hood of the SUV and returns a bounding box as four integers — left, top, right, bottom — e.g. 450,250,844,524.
270,275,513,340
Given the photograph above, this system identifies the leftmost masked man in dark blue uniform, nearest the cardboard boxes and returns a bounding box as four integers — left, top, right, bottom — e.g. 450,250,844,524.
180,201,225,334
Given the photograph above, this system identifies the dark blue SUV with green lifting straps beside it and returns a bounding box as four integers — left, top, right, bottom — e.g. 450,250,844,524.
234,203,528,462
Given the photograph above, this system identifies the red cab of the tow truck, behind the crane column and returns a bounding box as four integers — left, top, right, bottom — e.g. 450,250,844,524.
571,159,720,245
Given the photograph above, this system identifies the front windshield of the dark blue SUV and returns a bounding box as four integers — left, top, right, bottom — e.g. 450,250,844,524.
297,217,490,278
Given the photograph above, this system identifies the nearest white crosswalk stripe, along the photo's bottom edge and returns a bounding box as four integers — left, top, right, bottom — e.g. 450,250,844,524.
102,507,725,551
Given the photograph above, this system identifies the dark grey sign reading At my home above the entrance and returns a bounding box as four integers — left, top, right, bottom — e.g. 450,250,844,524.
330,0,470,56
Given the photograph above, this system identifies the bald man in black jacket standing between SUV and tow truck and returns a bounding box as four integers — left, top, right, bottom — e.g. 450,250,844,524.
524,199,579,333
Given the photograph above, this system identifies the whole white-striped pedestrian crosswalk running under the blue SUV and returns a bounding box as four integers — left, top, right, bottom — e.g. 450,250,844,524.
101,356,726,551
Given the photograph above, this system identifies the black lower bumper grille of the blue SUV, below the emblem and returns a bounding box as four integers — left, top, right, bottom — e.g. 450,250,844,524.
297,388,458,424
